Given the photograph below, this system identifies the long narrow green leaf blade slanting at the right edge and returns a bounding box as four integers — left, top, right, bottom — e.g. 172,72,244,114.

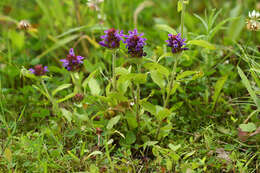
237,66,260,109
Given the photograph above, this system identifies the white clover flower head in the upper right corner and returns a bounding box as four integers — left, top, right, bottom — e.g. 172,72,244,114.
247,10,260,31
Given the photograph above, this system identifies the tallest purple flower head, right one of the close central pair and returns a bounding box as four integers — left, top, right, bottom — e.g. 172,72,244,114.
124,29,147,57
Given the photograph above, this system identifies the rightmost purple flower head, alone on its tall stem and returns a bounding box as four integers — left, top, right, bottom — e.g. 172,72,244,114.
166,33,188,53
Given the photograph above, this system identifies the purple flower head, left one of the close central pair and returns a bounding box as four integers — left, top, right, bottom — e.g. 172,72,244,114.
99,28,123,49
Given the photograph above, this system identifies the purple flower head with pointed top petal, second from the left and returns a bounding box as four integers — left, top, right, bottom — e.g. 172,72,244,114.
60,48,84,71
